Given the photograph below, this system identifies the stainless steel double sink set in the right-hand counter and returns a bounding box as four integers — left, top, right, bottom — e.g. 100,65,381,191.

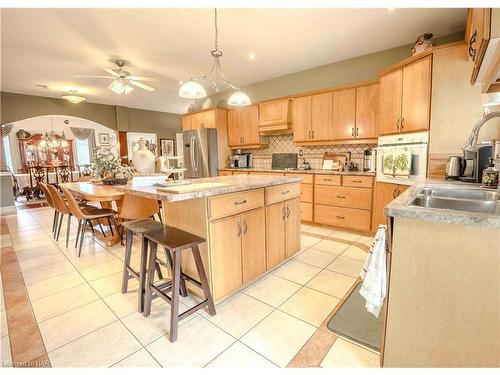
408,187,500,215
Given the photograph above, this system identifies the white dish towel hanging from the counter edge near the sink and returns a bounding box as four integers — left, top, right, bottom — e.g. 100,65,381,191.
359,225,387,318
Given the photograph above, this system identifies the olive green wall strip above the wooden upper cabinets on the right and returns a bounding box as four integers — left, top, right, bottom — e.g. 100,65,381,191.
211,32,464,107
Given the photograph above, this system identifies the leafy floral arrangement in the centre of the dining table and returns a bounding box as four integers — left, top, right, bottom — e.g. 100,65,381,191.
90,152,130,185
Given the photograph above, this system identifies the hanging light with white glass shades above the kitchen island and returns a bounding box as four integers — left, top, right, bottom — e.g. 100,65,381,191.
179,8,251,107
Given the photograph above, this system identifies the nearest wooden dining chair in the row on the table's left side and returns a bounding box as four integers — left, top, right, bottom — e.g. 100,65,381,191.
61,186,118,256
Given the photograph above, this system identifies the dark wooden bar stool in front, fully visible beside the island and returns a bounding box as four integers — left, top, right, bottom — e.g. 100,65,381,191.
144,225,215,342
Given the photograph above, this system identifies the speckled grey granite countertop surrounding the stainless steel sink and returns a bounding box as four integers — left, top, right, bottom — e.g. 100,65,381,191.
384,179,500,228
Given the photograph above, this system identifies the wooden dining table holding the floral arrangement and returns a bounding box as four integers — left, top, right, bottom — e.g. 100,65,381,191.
60,181,125,247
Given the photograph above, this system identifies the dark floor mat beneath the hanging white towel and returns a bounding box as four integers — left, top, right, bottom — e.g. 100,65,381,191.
327,282,383,351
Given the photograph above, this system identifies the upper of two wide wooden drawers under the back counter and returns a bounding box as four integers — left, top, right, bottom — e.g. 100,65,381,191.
314,204,371,232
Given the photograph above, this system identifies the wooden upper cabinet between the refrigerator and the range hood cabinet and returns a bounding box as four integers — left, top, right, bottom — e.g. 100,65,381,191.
227,105,260,147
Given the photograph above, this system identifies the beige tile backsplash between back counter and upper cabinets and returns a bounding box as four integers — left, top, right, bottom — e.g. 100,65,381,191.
244,134,376,169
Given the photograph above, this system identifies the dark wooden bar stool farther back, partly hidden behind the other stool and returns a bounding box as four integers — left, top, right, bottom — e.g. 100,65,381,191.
122,219,163,312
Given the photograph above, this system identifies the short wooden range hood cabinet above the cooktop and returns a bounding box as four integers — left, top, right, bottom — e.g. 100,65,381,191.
259,99,292,132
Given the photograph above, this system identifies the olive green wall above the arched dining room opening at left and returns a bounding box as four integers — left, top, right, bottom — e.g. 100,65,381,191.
0,92,182,138
